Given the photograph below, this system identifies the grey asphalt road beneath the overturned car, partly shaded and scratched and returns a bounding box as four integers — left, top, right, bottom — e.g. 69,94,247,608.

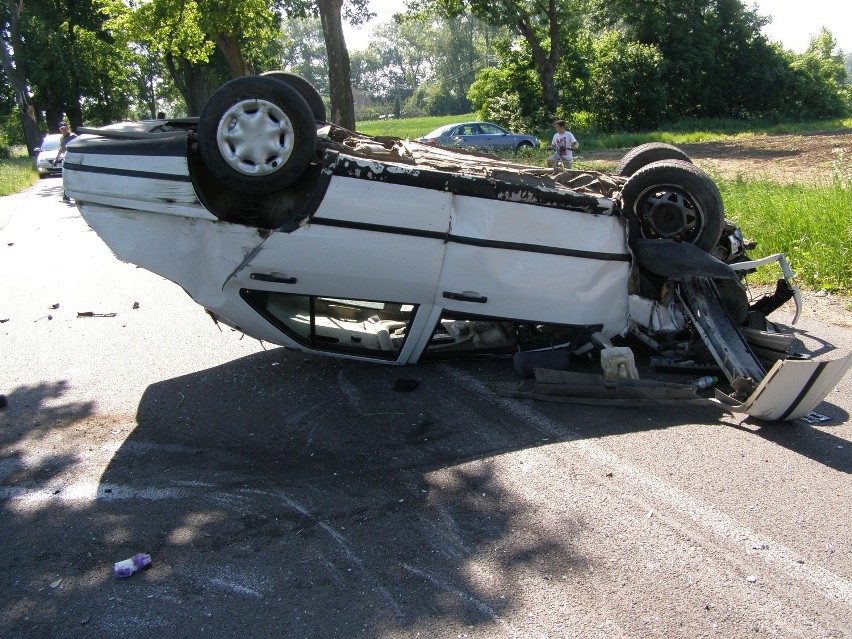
0,180,852,639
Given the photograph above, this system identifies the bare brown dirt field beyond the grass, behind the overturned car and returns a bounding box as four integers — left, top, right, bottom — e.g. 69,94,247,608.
582,129,852,183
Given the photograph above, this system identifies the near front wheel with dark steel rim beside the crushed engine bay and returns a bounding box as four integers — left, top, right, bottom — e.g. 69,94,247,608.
621,160,725,252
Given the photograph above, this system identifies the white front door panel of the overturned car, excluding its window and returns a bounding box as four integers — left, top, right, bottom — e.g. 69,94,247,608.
435,196,630,335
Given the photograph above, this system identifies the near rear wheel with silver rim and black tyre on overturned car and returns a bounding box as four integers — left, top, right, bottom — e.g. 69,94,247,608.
198,76,317,194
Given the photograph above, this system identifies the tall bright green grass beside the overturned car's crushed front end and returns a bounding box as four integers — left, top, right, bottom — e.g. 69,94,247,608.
717,179,852,295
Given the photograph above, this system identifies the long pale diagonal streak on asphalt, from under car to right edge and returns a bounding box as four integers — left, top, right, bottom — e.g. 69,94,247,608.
442,365,852,604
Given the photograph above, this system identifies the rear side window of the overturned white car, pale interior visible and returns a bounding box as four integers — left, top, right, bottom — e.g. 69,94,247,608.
240,289,416,359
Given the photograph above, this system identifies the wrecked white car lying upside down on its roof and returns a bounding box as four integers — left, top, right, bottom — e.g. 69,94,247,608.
64,72,852,420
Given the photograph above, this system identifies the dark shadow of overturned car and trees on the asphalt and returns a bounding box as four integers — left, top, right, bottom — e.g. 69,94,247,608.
0,349,850,637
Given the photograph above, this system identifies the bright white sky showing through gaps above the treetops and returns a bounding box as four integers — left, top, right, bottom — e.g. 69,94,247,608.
343,0,852,53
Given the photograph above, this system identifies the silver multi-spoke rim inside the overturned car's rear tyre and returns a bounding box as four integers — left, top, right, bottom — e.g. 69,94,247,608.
216,98,295,176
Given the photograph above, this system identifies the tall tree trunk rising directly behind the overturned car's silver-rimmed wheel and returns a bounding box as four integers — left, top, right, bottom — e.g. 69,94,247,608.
317,0,355,130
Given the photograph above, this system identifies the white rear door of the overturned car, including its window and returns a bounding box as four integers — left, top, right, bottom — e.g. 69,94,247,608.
224,172,450,362
